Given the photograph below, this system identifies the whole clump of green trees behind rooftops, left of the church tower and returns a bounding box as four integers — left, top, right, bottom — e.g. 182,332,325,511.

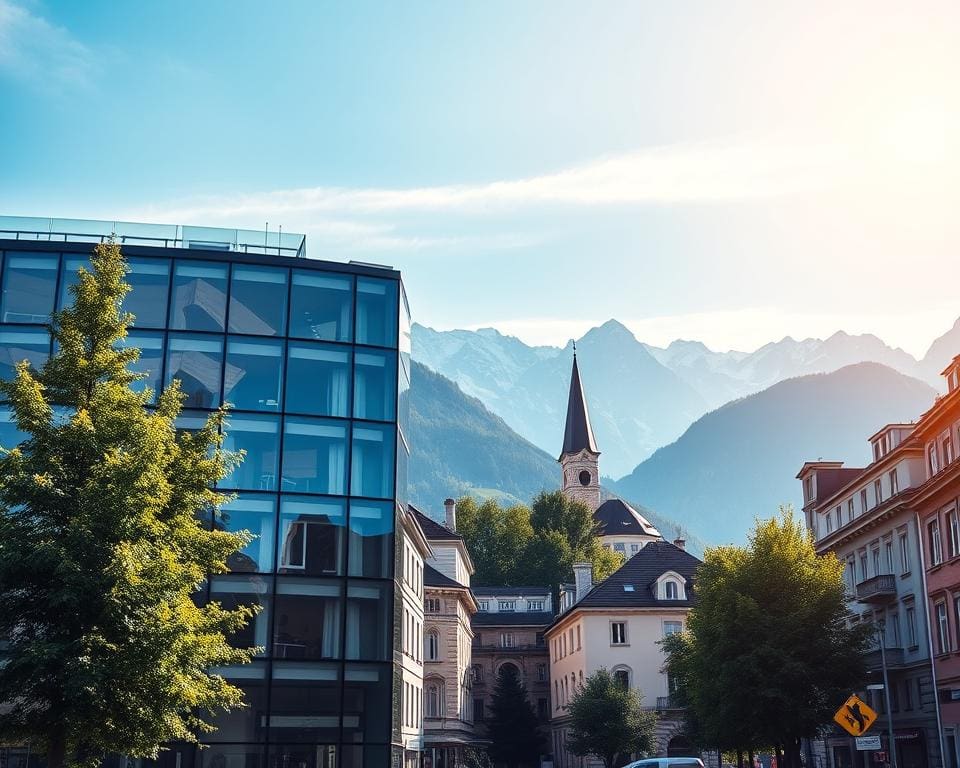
457,491,623,589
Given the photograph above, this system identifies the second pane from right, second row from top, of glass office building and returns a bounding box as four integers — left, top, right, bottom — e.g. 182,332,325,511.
284,342,350,416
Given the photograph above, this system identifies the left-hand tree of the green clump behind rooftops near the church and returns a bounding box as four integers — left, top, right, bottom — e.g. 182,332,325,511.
457,496,533,586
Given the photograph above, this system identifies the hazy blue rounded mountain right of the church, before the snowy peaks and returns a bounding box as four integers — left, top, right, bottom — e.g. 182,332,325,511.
613,362,937,543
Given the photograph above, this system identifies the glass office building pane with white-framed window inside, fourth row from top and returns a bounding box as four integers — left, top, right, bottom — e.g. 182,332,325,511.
277,496,347,576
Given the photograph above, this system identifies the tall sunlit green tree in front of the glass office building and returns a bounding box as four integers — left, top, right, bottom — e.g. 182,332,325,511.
0,243,253,768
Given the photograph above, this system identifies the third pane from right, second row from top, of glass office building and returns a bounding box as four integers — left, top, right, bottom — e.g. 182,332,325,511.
223,337,283,411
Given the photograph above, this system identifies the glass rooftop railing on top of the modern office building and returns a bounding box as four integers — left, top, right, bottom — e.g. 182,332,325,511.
0,216,307,258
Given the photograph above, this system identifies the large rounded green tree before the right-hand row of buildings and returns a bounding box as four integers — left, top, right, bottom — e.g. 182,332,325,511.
663,509,871,764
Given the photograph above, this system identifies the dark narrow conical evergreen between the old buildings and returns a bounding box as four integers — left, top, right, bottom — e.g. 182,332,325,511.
487,664,543,768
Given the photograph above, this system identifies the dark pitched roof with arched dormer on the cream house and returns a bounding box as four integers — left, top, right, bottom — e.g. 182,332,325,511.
574,541,700,609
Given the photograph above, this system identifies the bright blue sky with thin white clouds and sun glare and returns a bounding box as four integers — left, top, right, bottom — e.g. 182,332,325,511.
0,0,960,354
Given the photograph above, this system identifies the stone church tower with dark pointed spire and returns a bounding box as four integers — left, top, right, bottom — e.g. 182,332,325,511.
558,347,600,512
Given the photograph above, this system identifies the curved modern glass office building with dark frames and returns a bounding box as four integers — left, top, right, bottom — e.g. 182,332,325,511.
0,218,410,768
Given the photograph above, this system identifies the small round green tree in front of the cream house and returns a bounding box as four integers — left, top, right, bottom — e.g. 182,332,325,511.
567,669,657,768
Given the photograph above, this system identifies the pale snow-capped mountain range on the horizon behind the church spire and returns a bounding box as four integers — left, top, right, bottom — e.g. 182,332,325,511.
413,319,960,477
